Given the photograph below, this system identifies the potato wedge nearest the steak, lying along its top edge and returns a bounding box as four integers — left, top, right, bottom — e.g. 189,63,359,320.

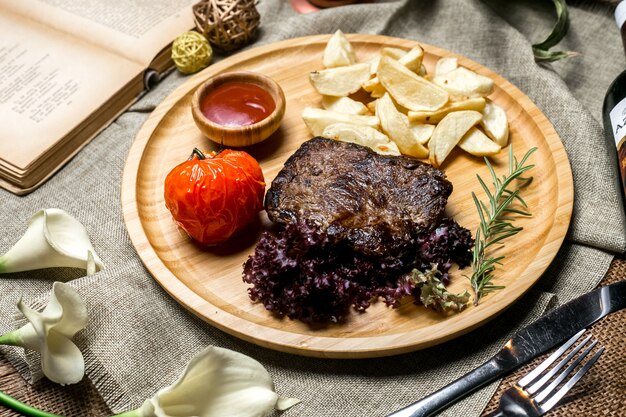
322,123,400,155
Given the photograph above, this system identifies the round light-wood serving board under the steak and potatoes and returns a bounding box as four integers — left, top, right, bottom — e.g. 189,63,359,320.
122,35,573,358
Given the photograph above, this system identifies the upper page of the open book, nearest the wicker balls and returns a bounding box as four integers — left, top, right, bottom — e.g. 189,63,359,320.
0,0,196,68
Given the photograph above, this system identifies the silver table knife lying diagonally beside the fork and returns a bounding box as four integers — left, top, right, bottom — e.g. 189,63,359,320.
387,281,626,417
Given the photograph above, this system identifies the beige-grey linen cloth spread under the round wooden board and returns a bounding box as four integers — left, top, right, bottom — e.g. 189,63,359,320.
0,0,625,417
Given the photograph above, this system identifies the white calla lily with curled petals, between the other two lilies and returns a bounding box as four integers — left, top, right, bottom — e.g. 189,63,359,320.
0,282,87,385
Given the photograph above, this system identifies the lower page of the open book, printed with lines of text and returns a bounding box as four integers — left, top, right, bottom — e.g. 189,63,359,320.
0,12,144,173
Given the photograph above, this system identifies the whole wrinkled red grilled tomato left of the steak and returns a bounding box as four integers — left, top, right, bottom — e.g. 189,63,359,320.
164,148,265,245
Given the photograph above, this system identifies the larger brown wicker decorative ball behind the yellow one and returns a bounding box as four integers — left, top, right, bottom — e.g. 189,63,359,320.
193,0,261,52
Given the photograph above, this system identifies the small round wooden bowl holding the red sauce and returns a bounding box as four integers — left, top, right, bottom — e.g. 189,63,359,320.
191,71,285,147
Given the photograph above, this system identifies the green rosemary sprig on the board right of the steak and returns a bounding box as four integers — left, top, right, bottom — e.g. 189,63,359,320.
469,146,537,305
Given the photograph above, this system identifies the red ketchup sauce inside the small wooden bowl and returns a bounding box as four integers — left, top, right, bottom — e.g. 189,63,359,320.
200,82,276,126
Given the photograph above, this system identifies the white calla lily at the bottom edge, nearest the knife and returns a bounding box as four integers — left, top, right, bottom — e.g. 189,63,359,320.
118,346,300,417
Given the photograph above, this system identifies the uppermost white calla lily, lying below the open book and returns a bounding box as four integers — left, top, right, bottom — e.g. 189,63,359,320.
0,208,104,273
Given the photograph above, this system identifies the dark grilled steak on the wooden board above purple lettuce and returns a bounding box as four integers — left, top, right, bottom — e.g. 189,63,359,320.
265,137,452,257
